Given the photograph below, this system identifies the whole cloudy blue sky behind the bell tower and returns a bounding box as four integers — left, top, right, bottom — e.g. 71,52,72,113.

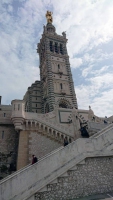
0,0,113,116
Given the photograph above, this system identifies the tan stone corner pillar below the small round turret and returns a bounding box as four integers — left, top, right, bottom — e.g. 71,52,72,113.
17,131,29,170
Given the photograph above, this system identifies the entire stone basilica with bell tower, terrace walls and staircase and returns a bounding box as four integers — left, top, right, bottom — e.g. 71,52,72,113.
0,11,113,200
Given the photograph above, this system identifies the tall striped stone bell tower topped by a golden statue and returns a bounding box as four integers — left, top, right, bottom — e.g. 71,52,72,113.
37,11,77,113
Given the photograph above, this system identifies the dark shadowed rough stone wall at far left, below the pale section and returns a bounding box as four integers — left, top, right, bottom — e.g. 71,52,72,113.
0,124,18,179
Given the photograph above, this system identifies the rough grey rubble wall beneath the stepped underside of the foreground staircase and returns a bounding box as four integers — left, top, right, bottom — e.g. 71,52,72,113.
35,157,113,200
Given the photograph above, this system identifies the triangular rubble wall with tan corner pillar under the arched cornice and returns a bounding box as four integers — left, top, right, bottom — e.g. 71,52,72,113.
17,130,63,170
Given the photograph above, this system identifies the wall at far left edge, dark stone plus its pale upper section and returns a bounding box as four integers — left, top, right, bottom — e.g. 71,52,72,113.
0,105,18,179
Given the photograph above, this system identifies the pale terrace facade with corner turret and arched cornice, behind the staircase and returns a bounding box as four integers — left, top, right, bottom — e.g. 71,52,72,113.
11,96,111,169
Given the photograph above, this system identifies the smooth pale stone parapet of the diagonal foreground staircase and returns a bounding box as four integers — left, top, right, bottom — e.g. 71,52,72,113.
0,126,113,200
